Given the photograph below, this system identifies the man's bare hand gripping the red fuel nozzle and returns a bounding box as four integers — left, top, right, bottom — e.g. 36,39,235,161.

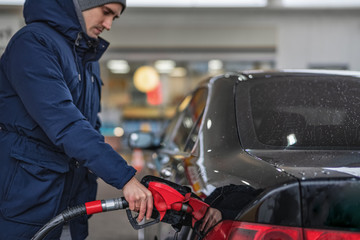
122,177,153,222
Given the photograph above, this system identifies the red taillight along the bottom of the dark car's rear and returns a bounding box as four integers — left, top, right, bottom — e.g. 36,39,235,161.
204,221,360,240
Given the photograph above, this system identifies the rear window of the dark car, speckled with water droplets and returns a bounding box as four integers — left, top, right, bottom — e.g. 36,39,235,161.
238,76,360,149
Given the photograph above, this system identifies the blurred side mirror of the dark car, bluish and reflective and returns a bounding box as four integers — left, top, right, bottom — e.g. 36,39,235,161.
128,131,159,149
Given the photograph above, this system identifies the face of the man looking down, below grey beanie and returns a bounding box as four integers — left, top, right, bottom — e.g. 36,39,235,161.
83,3,123,38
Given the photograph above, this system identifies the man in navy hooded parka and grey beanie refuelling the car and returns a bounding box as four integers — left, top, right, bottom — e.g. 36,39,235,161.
0,0,153,240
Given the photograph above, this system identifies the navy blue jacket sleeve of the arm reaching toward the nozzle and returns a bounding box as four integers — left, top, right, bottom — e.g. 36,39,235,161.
6,29,135,189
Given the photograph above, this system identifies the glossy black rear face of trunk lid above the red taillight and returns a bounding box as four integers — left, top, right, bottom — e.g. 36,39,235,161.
301,178,360,231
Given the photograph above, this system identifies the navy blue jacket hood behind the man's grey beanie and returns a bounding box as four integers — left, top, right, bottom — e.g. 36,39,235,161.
23,0,84,40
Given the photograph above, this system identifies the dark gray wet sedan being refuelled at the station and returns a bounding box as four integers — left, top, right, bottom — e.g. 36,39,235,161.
130,70,360,240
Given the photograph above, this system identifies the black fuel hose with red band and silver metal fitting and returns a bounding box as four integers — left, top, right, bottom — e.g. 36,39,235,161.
31,198,129,240
